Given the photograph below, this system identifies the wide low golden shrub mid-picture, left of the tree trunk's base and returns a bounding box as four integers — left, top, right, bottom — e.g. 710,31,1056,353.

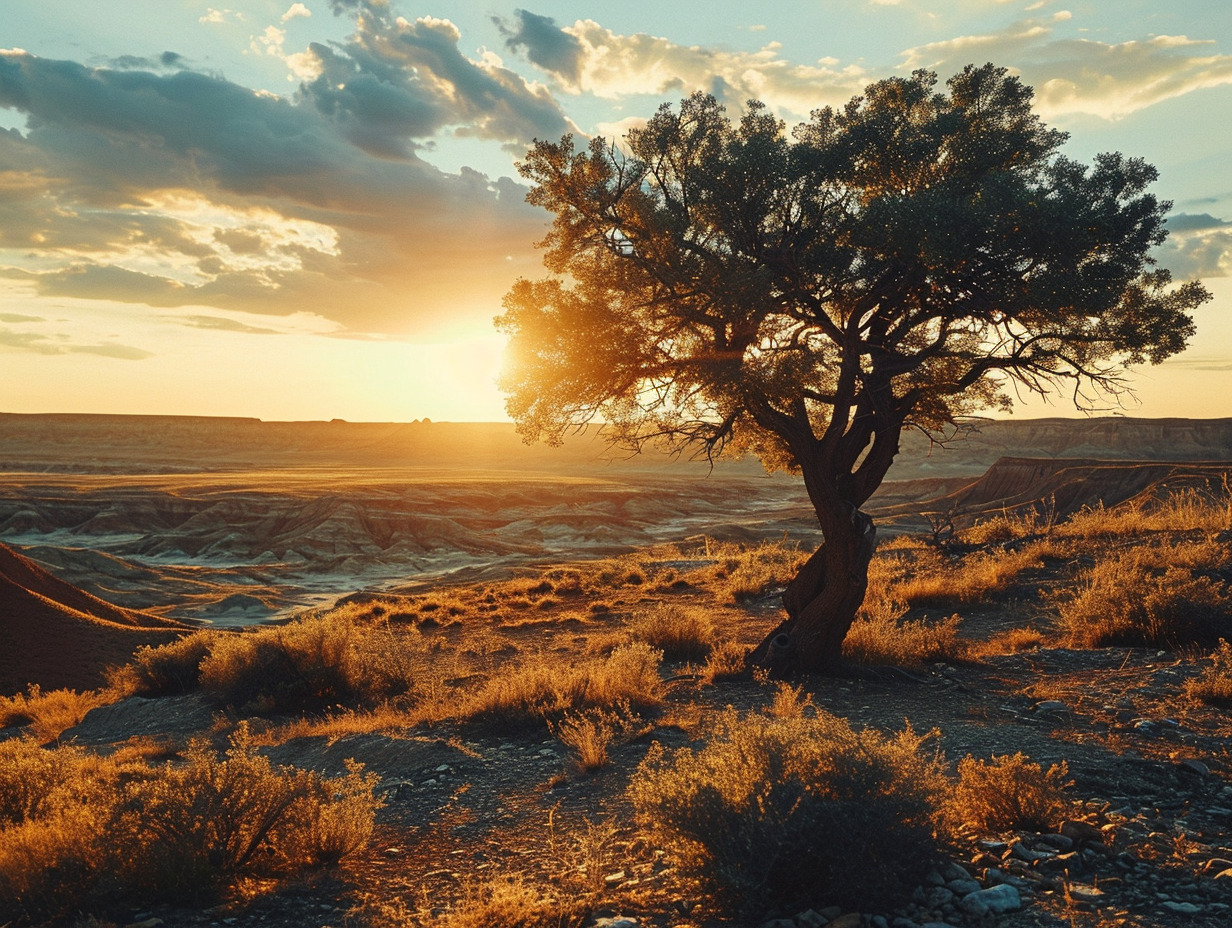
451,641,663,728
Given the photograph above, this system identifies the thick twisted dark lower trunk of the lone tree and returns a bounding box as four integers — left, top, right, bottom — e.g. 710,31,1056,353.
748,507,876,677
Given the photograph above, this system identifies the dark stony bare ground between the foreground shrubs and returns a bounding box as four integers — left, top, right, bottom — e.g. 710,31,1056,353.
36,569,1232,928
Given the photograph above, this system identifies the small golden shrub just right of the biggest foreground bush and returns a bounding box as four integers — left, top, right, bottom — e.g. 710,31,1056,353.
949,753,1072,832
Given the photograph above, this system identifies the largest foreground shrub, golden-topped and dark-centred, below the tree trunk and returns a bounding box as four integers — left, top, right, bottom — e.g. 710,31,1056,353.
630,711,945,917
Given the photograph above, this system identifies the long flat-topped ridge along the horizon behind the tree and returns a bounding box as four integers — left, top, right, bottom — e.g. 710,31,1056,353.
7,413,1232,481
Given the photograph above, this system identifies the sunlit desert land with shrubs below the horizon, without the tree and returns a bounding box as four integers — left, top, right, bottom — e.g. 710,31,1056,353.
7,415,1232,928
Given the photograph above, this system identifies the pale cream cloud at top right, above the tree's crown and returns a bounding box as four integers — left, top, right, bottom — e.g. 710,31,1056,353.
903,17,1232,120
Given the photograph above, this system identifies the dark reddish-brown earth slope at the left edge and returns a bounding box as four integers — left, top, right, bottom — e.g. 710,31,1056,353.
0,545,188,695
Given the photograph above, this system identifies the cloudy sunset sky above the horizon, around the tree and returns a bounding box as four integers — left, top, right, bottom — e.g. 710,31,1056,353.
0,0,1232,421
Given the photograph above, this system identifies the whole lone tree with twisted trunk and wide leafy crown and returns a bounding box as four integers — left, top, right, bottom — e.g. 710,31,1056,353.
496,64,1209,674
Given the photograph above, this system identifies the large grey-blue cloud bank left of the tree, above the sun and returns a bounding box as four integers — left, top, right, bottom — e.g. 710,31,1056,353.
0,41,549,336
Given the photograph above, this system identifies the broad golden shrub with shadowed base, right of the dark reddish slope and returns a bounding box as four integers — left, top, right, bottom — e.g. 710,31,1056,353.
201,613,413,712
